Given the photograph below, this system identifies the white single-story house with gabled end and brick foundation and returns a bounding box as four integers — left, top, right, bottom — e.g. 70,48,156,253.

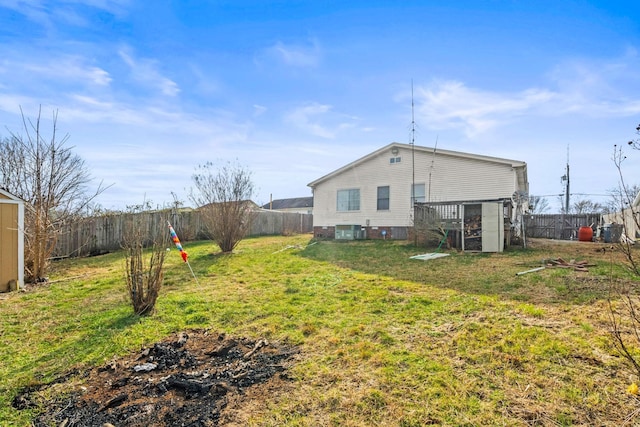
308,142,529,250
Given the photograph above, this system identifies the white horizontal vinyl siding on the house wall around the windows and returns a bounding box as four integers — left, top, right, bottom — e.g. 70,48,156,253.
313,147,517,226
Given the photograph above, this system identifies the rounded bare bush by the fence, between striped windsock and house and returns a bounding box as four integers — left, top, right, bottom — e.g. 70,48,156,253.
189,162,255,252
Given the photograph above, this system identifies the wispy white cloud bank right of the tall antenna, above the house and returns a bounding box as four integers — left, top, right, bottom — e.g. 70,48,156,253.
412,51,640,137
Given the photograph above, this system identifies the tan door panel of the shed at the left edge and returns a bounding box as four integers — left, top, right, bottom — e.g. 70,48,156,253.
0,203,20,292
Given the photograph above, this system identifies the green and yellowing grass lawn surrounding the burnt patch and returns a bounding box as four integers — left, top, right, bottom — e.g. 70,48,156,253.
0,235,640,426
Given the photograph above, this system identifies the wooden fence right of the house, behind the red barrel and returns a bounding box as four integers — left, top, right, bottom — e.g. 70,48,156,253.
524,213,601,240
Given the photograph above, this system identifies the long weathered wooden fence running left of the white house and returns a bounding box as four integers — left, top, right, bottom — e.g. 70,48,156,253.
53,210,313,257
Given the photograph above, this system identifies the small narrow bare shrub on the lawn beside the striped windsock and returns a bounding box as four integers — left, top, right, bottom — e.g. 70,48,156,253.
122,204,169,316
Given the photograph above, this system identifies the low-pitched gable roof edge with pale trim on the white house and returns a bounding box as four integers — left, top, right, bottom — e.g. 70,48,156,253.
307,142,529,191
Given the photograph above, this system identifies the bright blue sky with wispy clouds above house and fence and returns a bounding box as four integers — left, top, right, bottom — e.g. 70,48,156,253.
0,0,640,210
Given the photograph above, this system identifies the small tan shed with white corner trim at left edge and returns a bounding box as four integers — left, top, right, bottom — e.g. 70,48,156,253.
0,189,24,292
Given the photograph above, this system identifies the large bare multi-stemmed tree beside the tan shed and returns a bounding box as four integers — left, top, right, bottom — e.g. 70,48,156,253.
0,110,106,281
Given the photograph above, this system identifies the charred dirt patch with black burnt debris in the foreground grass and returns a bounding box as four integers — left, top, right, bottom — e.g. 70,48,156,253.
13,331,298,427
